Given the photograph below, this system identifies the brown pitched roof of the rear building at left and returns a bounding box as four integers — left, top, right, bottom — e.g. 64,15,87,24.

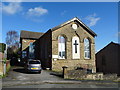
20,30,44,39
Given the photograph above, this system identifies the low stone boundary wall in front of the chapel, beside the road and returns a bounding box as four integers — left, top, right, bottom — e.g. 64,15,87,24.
63,67,118,80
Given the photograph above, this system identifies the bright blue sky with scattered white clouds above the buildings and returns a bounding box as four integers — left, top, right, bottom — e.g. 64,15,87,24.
0,2,120,51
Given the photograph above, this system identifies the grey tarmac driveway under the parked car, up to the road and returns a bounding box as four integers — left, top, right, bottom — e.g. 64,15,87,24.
3,67,62,82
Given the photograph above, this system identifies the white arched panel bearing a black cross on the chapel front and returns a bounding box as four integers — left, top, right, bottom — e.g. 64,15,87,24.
72,36,80,59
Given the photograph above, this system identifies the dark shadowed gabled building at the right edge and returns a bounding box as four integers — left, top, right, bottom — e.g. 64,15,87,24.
96,42,120,75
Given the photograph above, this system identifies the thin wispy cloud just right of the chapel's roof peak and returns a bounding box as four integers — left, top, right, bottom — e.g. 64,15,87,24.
85,13,100,27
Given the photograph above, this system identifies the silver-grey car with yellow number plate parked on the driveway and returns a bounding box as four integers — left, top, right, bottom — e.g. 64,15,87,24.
25,59,42,73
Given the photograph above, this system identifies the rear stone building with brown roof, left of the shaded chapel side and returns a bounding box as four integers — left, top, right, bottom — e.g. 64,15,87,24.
20,30,43,62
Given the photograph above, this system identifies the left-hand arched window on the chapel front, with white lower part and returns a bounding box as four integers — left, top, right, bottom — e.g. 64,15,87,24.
58,36,66,59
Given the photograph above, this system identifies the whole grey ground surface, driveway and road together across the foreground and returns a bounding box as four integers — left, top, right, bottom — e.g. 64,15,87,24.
2,67,120,88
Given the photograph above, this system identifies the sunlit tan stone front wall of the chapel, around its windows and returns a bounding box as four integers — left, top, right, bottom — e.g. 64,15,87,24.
52,22,96,72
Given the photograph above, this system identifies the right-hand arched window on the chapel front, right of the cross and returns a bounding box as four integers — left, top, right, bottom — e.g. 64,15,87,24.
84,38,90,59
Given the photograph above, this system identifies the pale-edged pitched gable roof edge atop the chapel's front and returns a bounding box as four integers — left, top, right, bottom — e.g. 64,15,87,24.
51,17,97,36
